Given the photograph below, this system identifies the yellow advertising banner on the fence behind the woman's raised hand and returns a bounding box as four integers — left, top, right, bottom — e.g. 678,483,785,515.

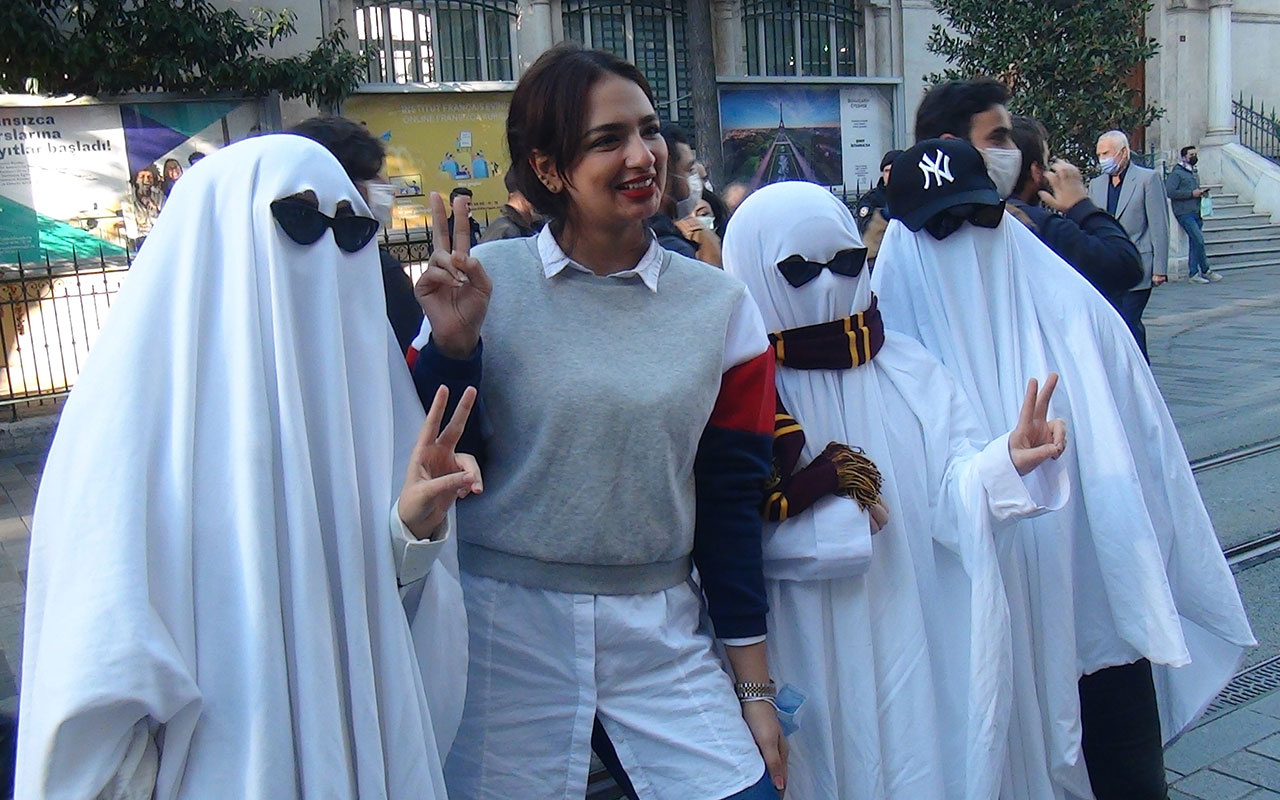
342,91,511,230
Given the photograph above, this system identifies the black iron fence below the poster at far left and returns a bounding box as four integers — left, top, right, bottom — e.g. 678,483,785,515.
0,251,129,413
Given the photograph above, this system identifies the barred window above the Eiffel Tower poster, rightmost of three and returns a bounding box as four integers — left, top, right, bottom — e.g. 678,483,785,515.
742,0,859,77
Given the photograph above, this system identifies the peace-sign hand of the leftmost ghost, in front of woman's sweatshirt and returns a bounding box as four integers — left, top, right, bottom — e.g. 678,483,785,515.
397,387,484,539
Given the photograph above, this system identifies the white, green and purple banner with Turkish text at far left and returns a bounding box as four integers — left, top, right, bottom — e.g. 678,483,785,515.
0,100,261,264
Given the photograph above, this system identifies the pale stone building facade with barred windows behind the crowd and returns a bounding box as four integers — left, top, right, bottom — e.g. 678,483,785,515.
220,0,1280,180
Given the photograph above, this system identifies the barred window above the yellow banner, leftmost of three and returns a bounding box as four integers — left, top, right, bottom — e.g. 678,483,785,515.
356,0,516,83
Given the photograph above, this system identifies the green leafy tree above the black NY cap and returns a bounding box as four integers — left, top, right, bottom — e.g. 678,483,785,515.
928,0,1164,165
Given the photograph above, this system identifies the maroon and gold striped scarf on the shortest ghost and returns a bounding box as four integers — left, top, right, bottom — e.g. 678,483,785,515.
764,294,884,522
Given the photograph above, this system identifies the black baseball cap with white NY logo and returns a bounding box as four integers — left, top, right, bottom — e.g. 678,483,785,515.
888,138,1005,238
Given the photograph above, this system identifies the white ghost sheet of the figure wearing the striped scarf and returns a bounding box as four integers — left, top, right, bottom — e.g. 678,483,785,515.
724,182,1069,800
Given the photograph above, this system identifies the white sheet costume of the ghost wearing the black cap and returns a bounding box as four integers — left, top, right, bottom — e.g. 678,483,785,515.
872,208,1254,800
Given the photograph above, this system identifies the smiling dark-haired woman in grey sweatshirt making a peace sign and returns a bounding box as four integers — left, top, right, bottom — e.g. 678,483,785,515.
415,46,786,800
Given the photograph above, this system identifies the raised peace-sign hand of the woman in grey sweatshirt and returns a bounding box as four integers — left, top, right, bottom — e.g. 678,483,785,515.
413,192,493,358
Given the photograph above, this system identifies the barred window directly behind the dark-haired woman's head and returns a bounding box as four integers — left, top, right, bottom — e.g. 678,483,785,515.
561,0,710,128
